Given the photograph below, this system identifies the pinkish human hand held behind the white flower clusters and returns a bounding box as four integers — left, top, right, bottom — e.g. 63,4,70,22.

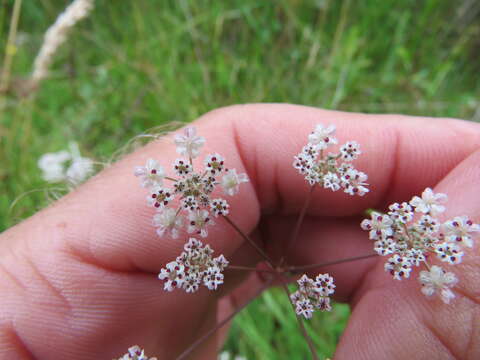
0,105,480,359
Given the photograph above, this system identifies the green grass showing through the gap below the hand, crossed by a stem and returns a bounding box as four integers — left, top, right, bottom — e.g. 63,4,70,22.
225,289,350,360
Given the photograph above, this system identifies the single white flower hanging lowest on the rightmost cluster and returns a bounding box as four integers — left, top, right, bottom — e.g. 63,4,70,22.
418,265,458,304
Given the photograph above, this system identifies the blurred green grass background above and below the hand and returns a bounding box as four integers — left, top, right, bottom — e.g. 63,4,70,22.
0,0,480,359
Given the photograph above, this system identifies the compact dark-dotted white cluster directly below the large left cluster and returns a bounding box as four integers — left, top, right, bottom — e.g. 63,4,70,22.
158,238,228,293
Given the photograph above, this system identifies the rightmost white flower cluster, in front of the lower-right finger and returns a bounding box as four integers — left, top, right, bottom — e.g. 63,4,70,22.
361,188,480,304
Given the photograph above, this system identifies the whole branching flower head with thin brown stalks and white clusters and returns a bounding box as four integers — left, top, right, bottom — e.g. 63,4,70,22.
125,124,480,360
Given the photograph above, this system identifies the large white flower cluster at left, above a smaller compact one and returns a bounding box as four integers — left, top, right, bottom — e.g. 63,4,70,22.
135,127,248,238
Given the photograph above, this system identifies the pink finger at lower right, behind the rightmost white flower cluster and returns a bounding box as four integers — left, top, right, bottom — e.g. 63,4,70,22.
336,151,480,360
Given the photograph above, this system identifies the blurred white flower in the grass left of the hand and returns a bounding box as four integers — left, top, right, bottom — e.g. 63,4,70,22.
38,142,93,185
